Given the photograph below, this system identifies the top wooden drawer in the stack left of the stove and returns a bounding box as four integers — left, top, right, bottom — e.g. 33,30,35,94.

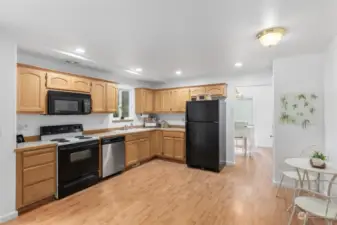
23,148,56,168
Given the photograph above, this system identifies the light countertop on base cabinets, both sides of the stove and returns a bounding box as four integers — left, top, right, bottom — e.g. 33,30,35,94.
15,128,185,152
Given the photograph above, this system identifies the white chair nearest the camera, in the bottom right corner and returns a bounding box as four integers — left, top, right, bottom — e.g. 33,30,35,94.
288,177,337,225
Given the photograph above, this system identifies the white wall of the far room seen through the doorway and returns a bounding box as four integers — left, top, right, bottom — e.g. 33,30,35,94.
237,85,274,148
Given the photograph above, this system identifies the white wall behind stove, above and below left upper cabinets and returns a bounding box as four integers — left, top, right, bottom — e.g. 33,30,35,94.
17,51,149,136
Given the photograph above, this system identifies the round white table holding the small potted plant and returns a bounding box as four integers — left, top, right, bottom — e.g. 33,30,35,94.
285,158,337,194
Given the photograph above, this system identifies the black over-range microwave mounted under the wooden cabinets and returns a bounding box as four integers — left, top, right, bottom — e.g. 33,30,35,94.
48,91,91,115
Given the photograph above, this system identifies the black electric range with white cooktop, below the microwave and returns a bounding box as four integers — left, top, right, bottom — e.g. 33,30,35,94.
40,124,99,199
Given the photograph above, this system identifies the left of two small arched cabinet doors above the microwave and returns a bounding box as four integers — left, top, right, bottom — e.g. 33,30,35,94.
47,72,72,90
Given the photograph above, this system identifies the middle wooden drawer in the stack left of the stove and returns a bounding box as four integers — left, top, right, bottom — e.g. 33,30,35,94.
23,163,55,186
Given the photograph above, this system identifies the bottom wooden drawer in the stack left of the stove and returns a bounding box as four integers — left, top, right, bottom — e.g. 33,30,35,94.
23,178,56,205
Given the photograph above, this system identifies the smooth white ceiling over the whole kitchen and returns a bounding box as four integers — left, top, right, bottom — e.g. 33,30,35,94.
0,0,337,81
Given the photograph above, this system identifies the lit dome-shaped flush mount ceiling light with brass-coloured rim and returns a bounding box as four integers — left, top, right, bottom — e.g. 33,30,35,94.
256,27,286,47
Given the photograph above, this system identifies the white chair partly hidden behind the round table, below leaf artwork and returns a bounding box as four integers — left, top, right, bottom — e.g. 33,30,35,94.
276,145,319,197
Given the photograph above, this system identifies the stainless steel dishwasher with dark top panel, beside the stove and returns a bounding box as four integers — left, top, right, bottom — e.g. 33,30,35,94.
101,137,125,178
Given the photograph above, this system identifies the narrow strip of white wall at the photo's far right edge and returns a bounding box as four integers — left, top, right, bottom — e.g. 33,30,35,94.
324,37,337,163
